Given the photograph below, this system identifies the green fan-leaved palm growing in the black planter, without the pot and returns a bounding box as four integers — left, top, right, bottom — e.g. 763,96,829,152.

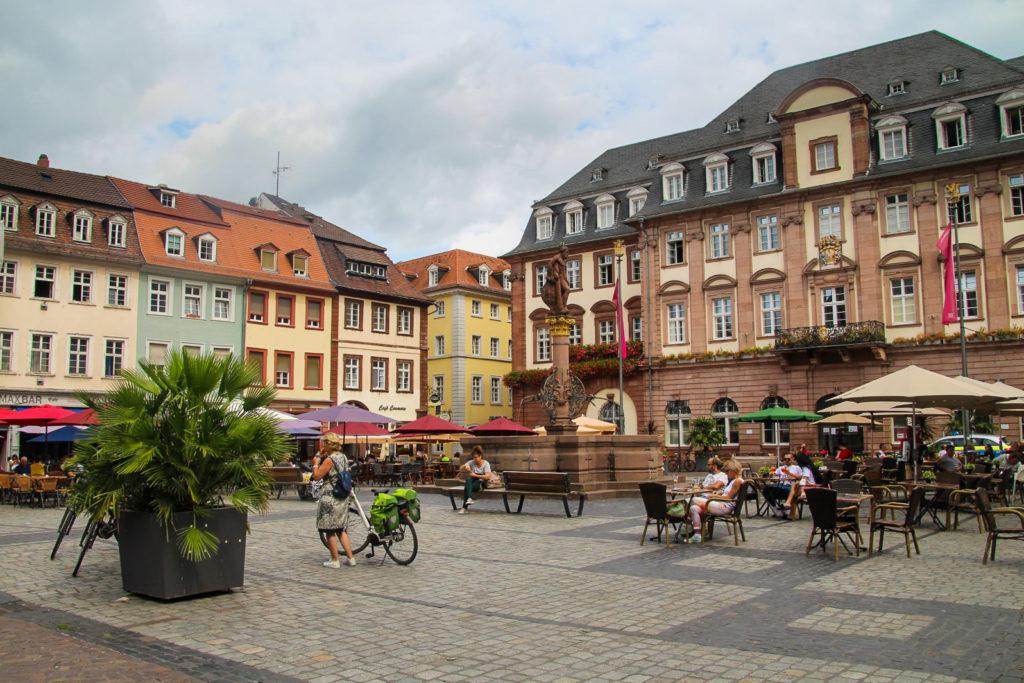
72,351,289,561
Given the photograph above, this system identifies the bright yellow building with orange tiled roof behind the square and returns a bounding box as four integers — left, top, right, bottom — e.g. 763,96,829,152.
398,249,513,426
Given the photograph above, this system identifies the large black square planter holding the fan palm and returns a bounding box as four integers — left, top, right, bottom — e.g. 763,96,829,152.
118,508,247,600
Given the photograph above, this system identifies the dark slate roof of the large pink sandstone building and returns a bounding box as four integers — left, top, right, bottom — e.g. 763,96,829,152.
506,31,1022,256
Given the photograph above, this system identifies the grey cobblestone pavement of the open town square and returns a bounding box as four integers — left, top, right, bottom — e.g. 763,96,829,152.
0,497,1024,682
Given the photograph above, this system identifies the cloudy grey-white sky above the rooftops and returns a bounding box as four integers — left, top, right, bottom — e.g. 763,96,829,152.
0,0,1024,259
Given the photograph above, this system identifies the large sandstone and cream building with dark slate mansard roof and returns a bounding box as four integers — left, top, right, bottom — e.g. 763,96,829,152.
504,32,1024,453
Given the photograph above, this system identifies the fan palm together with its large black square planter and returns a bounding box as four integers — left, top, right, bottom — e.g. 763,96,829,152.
73,351,288,600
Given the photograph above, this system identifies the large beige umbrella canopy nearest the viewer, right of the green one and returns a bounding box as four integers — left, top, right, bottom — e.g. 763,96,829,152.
839,366,1002,408
